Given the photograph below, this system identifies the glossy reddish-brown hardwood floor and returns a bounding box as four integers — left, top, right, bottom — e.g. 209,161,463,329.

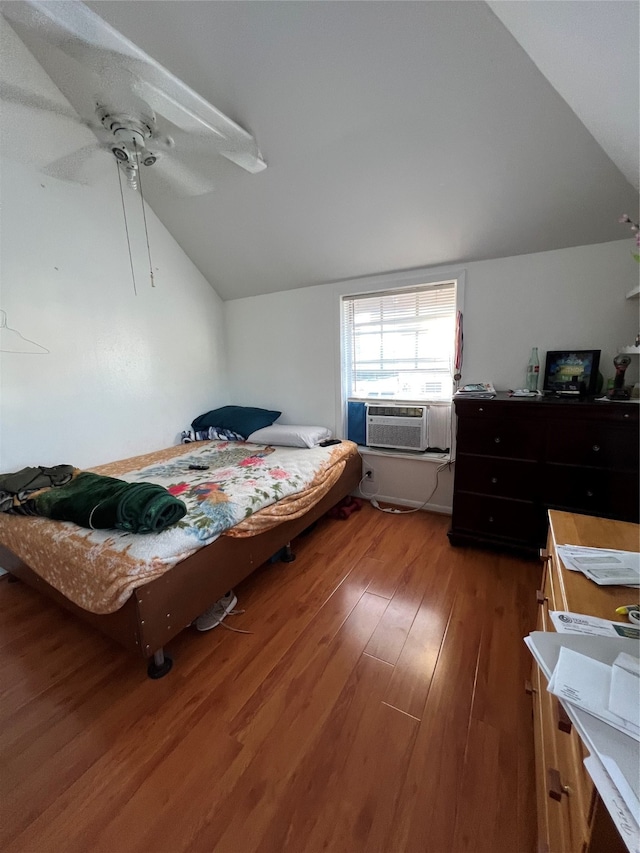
0,504,541,853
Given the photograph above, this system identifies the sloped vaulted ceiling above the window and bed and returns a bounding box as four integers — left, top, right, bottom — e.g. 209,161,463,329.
2,0,639,299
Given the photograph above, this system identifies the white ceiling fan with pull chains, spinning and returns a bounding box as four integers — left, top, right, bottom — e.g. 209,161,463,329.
0,0,267,196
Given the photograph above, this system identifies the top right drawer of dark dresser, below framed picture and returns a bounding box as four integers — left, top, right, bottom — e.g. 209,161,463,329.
546,421,639,471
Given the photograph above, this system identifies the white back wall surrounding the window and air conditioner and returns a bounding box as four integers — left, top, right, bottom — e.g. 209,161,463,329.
225,240,638,509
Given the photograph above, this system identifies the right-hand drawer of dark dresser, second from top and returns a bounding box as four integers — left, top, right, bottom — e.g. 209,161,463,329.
542,465,639,522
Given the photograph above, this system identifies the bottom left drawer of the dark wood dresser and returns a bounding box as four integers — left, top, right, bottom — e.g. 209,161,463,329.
453,491,545,543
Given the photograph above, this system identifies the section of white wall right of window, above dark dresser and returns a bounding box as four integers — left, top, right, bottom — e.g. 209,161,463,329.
464,239,640,389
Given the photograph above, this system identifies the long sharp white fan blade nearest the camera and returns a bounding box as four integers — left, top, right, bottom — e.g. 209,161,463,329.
3,0,267,173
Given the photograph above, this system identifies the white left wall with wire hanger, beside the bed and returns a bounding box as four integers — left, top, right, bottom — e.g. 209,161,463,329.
0,19,227,471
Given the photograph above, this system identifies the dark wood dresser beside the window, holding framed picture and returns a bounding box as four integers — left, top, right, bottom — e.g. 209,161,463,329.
449,394,640,554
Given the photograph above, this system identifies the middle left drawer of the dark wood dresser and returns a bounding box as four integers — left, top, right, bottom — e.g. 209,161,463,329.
456,454,540,501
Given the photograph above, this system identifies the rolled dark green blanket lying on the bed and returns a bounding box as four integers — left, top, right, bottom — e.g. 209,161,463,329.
27,471,187,533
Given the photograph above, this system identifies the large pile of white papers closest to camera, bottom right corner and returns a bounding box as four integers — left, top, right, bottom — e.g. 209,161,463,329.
525,631,640,853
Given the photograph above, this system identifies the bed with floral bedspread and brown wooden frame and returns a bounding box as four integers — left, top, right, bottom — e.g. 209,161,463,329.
0,441,362,678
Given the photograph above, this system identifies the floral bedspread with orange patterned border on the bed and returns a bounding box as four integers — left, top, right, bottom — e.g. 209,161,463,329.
0,441,357,613
